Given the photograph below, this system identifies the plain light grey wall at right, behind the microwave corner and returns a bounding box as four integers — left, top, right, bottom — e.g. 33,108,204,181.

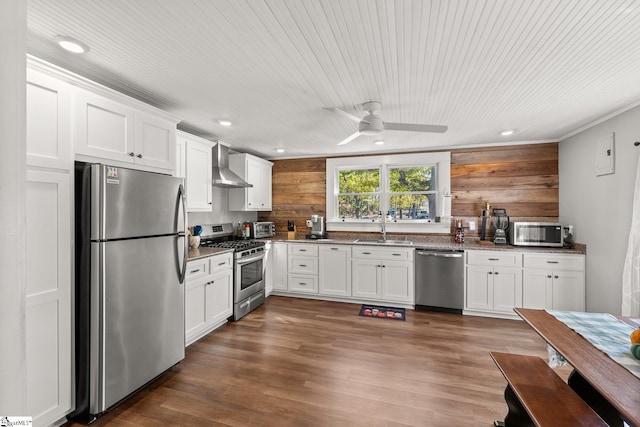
558,107,640,314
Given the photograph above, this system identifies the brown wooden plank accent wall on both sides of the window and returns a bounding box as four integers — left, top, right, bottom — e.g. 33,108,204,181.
258,142,559,236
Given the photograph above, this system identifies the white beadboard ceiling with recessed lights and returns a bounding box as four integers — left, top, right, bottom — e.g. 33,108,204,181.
27,0,640,159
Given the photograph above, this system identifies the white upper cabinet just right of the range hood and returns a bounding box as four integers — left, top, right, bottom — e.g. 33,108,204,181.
229,153,273,211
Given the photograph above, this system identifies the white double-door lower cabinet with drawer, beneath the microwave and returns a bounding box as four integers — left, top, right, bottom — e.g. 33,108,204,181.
522,254,585,311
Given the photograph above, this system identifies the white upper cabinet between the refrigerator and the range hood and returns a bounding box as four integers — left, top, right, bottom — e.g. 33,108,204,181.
176,131,214,212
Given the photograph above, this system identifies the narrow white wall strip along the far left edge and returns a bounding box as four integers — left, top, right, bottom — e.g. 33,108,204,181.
0,0,27,416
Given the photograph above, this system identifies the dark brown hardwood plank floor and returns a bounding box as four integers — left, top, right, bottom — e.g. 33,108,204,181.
69,296,546,426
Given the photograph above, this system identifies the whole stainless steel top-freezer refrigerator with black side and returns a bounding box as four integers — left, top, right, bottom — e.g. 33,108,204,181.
71,162,188,422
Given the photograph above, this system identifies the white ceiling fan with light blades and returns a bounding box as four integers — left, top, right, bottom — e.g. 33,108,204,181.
325,101,447,145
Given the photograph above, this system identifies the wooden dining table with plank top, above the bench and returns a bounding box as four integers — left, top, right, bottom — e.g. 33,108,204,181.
515,308,640,427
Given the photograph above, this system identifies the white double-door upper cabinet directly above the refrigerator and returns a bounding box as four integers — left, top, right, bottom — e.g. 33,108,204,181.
73,88,176,173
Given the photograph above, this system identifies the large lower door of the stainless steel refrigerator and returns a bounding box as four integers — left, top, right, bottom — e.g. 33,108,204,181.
90,236,185,414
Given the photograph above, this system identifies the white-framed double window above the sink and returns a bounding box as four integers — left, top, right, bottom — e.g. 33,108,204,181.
327,152,451,233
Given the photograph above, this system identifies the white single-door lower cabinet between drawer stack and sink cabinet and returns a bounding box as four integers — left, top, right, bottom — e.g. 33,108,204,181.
318,245,351,297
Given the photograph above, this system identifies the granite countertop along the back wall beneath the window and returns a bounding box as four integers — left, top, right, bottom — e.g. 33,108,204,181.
269,233,587,254
